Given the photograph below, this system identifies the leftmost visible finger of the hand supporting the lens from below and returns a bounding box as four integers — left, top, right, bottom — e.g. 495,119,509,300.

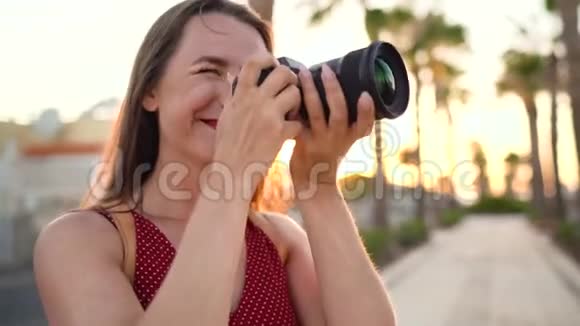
298,69,326,133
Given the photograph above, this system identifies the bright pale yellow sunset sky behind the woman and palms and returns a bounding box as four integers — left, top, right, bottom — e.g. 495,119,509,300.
0,0,577,199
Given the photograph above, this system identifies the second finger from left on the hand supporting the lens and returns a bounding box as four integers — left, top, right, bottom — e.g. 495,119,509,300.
322,65,348,132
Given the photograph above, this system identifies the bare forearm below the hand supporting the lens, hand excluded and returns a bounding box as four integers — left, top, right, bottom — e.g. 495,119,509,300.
297,185,395,326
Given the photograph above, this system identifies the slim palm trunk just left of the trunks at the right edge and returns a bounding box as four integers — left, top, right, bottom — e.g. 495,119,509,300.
525,97,545,217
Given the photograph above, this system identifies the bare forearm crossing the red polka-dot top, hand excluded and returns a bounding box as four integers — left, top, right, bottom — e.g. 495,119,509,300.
140,176,250,326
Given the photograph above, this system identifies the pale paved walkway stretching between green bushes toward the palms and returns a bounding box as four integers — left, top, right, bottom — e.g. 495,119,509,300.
384,216,580,326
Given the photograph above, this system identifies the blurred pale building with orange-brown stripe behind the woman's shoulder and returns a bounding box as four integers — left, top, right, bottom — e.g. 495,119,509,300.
0,103,112,269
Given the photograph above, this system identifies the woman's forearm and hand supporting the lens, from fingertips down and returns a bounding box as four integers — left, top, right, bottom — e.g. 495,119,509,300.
290,65,395,326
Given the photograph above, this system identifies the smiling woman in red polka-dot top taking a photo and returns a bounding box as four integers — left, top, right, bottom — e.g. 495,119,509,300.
34,0,394,326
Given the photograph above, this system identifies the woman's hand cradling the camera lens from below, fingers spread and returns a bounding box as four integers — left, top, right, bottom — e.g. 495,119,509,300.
290,65,375,196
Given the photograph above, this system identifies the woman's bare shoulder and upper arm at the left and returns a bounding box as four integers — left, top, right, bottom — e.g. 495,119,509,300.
34,211,141,326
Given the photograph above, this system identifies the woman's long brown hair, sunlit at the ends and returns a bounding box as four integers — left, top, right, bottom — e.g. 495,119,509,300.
81,0,289,211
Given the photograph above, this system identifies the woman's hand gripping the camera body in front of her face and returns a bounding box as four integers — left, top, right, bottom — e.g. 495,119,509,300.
214,55,302,193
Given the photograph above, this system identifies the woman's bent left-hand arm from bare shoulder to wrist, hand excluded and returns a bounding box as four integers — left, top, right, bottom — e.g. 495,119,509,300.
34,174,249,326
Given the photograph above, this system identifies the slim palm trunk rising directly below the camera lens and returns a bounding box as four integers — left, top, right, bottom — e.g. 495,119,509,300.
373,120,390,228
